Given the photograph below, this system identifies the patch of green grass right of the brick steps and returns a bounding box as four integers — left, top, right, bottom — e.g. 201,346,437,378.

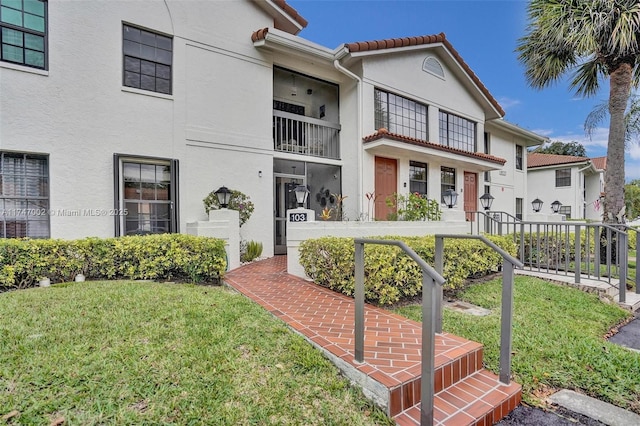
397,277,640,413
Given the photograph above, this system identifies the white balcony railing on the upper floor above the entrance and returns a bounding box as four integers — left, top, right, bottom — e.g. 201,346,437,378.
273,110,340,160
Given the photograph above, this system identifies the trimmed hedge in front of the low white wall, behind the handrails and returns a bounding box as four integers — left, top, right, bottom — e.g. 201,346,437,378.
300,236,516,304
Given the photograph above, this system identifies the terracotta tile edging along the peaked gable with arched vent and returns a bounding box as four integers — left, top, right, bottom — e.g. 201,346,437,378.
345,33,505,116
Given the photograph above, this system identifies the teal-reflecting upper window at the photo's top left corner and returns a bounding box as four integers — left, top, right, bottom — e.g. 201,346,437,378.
0,0,47,69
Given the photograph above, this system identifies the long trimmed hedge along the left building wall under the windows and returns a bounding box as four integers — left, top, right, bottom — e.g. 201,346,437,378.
0,234,227,288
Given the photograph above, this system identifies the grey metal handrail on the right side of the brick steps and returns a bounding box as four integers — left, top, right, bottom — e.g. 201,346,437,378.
435,234,524,385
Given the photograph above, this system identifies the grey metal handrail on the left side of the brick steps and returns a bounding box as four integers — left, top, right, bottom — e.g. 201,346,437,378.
354,238,445,425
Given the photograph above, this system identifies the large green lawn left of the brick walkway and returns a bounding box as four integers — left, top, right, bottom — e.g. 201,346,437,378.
0,281,390,425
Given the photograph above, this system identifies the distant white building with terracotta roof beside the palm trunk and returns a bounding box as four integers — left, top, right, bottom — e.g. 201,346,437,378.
528,152,607,221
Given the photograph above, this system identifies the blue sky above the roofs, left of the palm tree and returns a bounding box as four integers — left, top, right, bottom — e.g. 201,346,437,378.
287,0,640,181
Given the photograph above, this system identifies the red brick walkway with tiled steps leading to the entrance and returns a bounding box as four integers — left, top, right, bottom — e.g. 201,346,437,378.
225,256,520,425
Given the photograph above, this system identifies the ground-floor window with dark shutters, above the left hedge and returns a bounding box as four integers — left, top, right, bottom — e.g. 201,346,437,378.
114,154,178,235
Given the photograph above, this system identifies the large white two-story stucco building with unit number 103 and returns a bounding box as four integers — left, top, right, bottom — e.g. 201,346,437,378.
0,0,545,256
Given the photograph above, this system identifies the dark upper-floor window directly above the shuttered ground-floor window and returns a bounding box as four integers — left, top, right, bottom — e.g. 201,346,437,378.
122,24,173,94
